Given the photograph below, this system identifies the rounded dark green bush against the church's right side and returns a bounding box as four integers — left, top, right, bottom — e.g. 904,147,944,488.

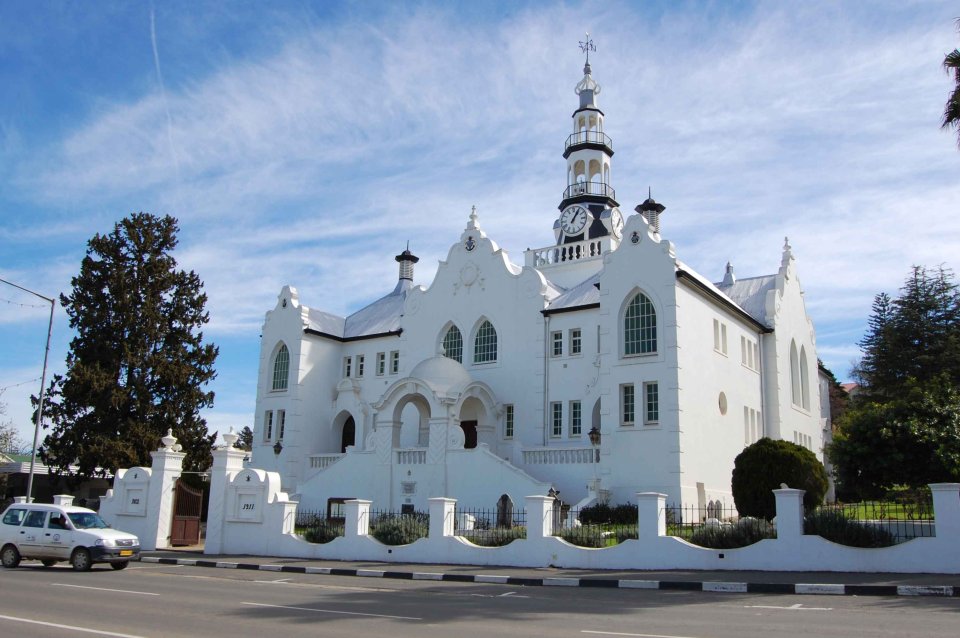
731,438,827,520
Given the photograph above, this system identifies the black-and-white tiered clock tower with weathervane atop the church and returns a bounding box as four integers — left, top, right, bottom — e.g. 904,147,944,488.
553,33,623,244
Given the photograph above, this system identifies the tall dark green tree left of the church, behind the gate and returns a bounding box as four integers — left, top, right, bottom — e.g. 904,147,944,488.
34,213,218,477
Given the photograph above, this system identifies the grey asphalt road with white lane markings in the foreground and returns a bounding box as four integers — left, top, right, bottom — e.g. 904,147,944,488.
0,562,960,638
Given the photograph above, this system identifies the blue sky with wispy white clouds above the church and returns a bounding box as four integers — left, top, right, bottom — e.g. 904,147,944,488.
0,1,960,450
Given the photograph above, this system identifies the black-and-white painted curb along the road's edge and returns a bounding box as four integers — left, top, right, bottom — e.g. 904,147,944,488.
140,556,960,597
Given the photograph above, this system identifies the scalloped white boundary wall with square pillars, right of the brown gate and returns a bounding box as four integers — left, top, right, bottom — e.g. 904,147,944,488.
204,448,960,574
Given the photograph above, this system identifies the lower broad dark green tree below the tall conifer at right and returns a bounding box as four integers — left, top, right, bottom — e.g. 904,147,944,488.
828,375,960,500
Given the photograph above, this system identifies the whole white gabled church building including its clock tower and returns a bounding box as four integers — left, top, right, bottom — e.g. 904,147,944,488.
251,51,823,512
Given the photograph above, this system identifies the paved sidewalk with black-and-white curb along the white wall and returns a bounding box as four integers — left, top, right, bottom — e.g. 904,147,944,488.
142,548,960,596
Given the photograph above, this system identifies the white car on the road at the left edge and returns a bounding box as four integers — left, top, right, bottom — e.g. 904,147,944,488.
0,503,140,571
